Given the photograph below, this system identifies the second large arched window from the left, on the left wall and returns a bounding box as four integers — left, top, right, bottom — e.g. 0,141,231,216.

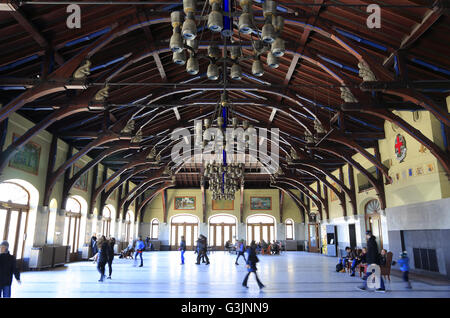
63,197,81,260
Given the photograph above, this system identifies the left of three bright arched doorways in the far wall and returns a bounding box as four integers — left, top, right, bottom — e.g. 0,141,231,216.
170,214,199,250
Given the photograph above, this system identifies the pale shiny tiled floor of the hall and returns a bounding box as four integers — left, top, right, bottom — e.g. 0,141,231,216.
12,252,450,298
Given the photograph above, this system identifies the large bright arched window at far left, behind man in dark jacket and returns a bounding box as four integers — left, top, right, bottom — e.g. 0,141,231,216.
0,182,30,262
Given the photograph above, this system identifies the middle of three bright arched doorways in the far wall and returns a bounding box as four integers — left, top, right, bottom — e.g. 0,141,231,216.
208,214,237,250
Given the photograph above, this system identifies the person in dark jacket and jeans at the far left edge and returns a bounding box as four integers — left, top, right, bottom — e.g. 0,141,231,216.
0,241,21,298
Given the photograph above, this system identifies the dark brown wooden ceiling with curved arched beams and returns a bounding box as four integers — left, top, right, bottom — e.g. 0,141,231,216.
0,0,450,214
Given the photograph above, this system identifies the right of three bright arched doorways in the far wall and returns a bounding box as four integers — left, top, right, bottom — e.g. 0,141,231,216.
247,214,275,244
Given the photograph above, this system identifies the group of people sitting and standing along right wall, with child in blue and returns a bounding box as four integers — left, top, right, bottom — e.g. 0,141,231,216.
336,231,412,292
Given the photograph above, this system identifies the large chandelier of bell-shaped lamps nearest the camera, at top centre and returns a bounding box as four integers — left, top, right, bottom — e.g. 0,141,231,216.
169,0,285,80
